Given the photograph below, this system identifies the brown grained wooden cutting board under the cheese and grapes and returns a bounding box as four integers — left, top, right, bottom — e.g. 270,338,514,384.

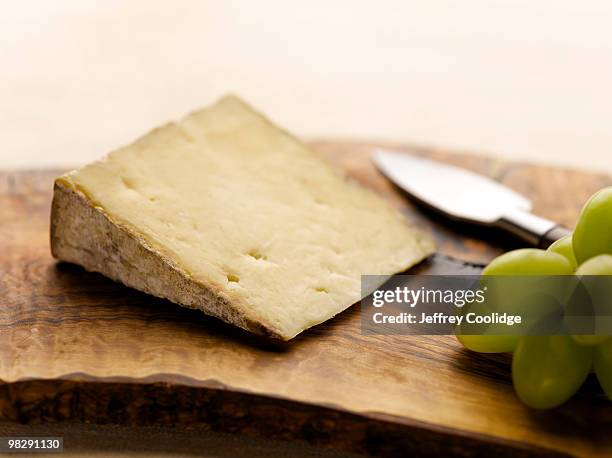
0,142,612,456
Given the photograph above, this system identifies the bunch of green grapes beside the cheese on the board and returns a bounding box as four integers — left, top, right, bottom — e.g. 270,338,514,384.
457,187,612,409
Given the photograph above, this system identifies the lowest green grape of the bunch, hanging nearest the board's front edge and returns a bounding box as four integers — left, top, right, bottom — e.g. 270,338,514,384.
512,336,593,409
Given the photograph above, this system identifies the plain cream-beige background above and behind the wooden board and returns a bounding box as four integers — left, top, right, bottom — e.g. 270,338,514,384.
0,0,612,171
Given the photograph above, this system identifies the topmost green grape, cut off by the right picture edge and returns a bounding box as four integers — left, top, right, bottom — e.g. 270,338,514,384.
572,186,612,264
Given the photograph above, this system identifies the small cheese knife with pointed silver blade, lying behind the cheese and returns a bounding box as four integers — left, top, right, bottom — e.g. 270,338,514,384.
372,149,570,248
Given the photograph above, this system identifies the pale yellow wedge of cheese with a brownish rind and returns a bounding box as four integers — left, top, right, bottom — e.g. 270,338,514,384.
51,96,433,340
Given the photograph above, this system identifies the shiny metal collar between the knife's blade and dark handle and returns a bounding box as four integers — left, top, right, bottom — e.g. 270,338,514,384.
496,209,571,249
